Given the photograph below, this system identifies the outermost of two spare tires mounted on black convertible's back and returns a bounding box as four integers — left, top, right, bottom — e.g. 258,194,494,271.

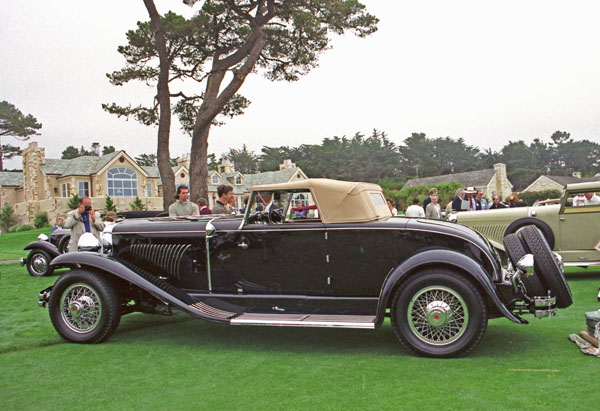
519,225,573,308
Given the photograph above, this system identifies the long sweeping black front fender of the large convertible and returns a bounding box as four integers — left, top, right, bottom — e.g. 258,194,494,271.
51,251,232,322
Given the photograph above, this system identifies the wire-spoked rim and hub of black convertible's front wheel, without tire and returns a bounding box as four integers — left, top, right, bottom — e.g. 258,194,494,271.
60,283,102,333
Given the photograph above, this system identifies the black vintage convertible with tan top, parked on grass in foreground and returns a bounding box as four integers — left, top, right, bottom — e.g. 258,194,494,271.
39,179,572,357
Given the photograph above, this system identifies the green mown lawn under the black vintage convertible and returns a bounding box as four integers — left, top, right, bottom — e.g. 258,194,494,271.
0,232,600,410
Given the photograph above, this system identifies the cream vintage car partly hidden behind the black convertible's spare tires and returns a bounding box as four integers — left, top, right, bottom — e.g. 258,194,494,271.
454,182,600,266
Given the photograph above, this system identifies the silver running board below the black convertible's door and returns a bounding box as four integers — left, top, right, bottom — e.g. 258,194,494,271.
230,313,376,330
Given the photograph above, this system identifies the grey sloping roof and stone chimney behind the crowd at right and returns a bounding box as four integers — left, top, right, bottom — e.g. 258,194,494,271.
402,163,513,198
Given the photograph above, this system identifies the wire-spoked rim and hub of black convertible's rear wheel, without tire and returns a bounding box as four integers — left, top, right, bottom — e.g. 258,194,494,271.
407,286,469,345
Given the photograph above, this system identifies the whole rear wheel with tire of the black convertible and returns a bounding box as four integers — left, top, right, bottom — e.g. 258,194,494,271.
391,269,487,357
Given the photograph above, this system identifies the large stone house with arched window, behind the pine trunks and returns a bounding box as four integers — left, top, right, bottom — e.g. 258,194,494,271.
0,142,308,224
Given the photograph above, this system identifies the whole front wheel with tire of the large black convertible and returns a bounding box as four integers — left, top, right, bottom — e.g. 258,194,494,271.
48,269,121,344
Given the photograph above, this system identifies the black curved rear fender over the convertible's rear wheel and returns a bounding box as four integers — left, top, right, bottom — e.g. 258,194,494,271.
377,250,524,325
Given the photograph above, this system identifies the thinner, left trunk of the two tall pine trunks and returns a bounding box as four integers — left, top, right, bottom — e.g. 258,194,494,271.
144,0,175,210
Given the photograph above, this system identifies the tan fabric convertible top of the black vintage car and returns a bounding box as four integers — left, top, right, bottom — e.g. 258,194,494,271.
250,178,392,223
